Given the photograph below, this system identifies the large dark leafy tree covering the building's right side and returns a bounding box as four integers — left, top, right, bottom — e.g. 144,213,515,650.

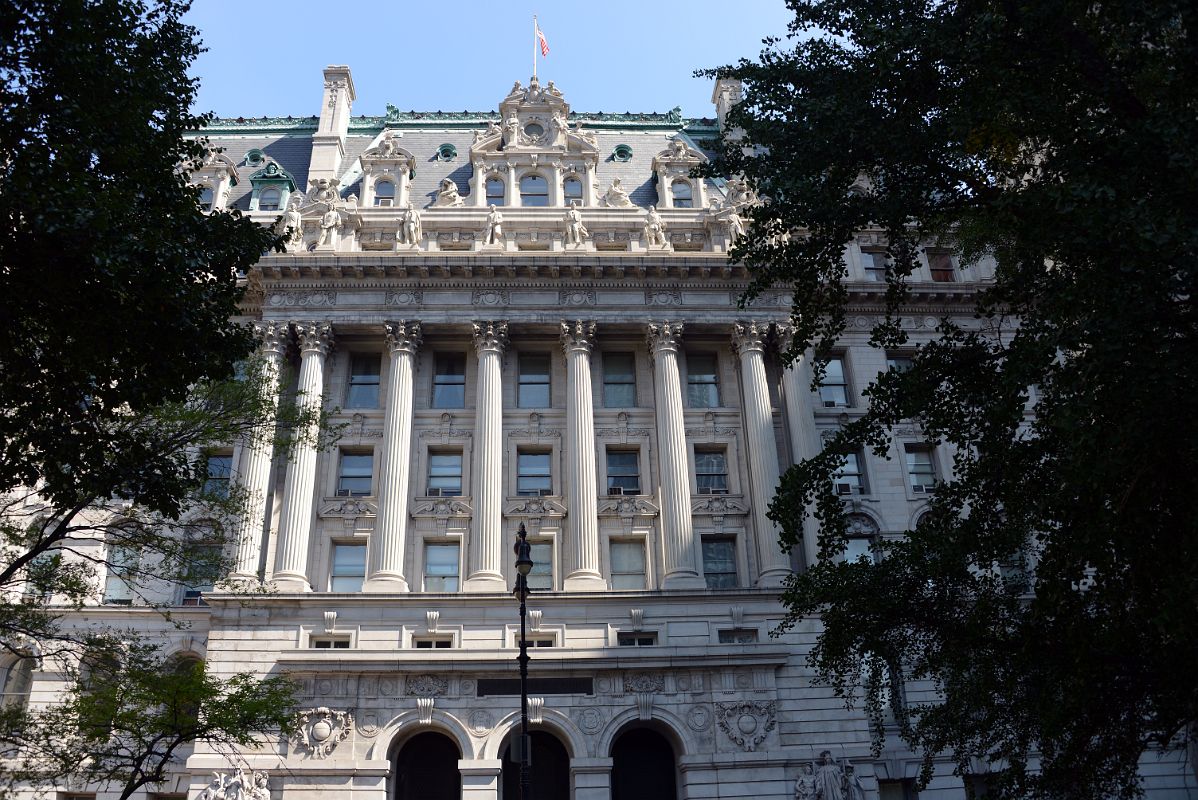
704,0,1198,798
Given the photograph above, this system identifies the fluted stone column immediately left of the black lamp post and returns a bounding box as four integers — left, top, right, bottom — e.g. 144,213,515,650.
462,322,508,592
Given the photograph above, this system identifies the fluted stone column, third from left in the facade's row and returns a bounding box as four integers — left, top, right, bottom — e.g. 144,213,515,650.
362,322,420,592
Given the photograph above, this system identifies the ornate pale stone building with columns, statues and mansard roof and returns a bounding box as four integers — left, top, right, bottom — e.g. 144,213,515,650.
4,67,1194,800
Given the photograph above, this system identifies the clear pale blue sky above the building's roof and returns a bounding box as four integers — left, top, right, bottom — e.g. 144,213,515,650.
189,0,791,117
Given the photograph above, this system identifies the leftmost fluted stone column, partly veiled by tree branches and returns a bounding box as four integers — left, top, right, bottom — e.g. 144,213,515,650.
230,322,288,583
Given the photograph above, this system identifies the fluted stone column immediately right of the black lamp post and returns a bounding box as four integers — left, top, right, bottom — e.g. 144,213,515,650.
562,320,607,592
